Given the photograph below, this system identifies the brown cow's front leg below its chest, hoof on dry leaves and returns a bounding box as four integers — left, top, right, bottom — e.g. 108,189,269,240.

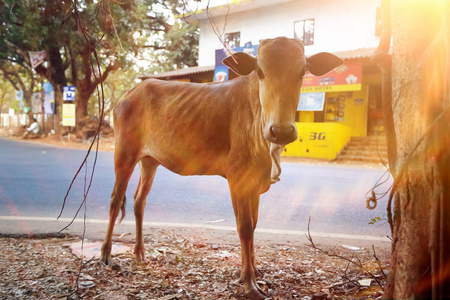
230,183,266,299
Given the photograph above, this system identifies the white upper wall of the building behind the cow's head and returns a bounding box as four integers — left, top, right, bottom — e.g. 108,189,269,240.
199,0,380,66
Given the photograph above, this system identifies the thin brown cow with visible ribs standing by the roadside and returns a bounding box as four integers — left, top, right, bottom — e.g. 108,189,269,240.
101,37,342,299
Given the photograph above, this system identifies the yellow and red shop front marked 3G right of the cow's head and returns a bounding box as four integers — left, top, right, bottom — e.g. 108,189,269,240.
282,59,382,160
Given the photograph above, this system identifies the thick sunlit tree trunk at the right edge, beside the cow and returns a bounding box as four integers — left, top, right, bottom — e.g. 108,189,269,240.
384,0,450,299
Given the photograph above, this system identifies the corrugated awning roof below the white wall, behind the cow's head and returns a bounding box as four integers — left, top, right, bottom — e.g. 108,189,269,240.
140,48,376,79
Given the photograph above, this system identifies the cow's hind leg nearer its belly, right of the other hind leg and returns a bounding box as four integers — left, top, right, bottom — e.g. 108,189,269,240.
134,157,159,261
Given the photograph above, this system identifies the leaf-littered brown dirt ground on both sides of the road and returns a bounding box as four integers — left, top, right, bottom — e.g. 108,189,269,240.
0,128,390,300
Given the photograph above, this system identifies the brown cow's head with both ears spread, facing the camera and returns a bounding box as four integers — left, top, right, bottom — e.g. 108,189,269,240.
223,37,342,145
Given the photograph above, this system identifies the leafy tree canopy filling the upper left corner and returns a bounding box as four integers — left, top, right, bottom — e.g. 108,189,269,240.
0,0,198,119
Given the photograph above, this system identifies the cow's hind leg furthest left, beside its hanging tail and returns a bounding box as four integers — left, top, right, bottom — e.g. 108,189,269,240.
101,150,136,265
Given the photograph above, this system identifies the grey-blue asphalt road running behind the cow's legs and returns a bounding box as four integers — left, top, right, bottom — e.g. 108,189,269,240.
0,138,390,246
